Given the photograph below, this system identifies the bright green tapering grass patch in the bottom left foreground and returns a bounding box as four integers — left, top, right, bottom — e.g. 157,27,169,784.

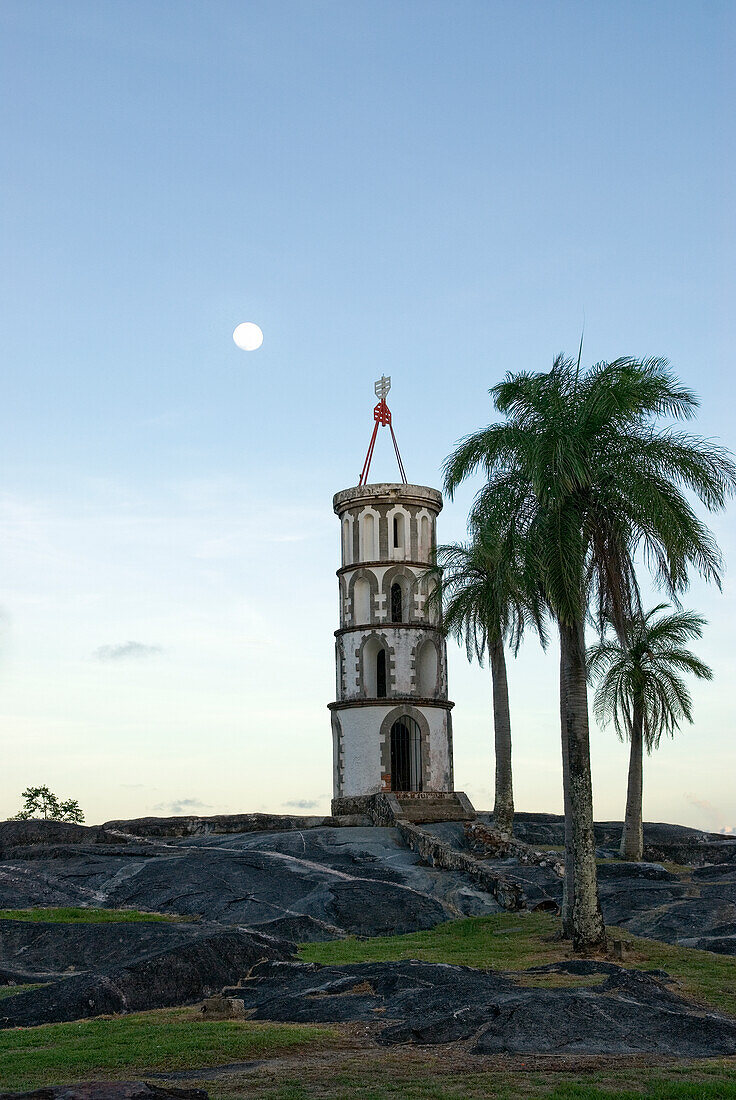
0,1009,340,1090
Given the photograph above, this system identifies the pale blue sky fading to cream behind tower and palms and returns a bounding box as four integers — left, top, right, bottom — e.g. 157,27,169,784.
0,0,736,828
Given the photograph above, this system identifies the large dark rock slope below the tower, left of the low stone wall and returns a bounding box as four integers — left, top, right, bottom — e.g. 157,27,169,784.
0,828,468,935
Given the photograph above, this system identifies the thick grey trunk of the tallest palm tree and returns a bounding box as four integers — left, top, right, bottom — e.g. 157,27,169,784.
560,620,606,952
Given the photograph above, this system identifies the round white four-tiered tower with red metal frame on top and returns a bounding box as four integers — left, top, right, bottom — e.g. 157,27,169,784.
330,378,455,813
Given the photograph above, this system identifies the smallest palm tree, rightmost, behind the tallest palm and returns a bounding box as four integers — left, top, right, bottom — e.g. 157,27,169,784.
587,604,713,860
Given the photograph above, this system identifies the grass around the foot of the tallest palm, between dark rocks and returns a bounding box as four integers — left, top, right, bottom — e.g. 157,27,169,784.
299,913,736,1016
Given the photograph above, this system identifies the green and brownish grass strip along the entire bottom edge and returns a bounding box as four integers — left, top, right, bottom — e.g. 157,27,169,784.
5,1009,736,1100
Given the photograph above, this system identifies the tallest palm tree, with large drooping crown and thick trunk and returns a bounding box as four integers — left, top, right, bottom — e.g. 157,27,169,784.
444,356,736,950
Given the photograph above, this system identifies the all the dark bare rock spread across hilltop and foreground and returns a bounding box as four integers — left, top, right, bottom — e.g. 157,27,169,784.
0,815,736,1056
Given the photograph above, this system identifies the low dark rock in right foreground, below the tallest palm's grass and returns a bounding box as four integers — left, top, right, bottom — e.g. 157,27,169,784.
223,961,736,1057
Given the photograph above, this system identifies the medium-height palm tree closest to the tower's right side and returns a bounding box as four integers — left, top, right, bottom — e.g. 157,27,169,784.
433,526,547,835
